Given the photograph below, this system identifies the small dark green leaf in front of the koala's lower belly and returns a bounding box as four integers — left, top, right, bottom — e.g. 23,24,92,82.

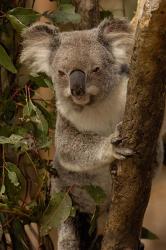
84,185,106,204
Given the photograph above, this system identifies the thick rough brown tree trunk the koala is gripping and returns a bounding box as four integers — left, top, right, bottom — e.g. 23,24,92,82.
102,0,166,250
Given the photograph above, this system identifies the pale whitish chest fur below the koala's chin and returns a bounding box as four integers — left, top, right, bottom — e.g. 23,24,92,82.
57,80,127,135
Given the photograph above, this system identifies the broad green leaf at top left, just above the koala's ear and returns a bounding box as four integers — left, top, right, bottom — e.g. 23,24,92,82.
8,7,41,26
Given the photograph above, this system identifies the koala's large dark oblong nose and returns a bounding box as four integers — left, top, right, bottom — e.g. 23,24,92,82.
70,70,85,96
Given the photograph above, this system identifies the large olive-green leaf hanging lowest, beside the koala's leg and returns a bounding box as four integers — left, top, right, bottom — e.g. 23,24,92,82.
40,192,72,235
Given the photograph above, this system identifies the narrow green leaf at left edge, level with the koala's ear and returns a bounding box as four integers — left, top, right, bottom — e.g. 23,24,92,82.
0,45,17,74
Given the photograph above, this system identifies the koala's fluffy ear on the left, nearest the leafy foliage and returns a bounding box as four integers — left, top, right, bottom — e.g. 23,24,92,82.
20,23,60,75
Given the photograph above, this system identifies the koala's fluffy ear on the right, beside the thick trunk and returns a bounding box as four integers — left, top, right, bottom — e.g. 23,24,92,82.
98,18,134,65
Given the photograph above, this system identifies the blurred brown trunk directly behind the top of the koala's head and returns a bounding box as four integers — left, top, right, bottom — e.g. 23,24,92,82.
73,0,100,29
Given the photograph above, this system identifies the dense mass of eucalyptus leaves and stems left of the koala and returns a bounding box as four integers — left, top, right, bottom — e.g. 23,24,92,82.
0,1,58,246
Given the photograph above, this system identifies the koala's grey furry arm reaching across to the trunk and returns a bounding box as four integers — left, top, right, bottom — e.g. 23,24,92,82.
55,115,123,171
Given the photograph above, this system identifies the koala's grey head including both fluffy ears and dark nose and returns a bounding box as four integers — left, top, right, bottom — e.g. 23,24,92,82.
21,19,132,107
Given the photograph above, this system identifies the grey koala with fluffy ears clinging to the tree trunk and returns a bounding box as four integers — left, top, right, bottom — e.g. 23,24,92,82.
21,19,164,250
